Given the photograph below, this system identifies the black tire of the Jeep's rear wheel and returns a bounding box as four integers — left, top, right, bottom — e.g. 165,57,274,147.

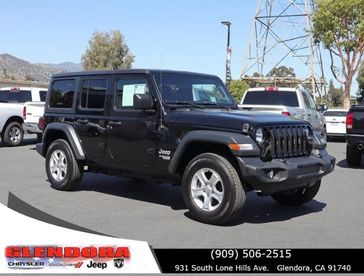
46,139,83,191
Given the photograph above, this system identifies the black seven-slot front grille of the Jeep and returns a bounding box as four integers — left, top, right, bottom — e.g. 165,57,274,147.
261,124,312,161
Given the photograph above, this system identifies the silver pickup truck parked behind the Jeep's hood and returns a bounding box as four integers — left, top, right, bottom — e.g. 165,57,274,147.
239,87,326,137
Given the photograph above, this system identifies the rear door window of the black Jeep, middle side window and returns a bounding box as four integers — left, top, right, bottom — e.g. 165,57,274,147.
81,79,107,110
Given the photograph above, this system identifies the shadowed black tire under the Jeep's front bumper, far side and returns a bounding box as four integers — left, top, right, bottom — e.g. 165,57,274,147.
271,180,321,206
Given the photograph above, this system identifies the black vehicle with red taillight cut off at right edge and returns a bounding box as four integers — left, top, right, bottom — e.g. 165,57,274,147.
346,100,364,166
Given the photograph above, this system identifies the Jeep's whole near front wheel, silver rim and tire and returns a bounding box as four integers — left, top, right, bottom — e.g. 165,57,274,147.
182,153,245,225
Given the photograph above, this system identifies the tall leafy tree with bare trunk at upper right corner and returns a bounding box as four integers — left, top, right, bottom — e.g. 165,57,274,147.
313,0,364,108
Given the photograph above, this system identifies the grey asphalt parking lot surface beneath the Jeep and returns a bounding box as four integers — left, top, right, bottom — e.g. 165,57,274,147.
0,136,364,248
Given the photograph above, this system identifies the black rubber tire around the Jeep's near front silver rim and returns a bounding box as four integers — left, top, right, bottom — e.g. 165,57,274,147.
182,153,246,225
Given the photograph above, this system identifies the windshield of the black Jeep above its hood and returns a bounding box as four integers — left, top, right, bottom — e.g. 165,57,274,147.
153,72,235,107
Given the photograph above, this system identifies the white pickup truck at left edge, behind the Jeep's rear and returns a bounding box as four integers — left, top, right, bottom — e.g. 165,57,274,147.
0,87,47,146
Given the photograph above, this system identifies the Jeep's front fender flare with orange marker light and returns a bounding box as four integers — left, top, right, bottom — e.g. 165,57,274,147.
168,130,260,173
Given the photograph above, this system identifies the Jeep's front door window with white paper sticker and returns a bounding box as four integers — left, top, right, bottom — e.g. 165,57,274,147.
114,77,149,109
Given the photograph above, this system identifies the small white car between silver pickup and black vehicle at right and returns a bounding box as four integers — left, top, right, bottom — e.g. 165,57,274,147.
323,109,348,139
